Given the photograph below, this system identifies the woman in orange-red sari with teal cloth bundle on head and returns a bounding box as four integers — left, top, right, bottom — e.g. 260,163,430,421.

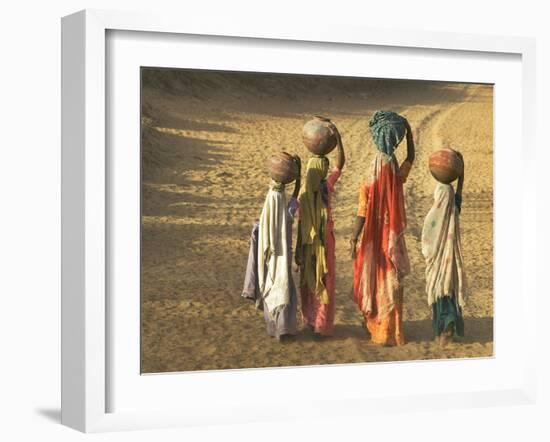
350,111,414,346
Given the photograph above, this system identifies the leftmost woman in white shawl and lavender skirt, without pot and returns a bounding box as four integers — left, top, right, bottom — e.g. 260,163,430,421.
242,155,301,341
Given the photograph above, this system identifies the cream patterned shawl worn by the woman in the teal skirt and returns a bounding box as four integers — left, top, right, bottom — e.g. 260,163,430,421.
422,183,466,307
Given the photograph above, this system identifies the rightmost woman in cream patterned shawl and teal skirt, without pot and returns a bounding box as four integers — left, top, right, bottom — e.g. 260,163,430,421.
422,155,466,344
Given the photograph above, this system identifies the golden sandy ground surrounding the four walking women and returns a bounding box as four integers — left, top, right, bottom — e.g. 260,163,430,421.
141,71,493,373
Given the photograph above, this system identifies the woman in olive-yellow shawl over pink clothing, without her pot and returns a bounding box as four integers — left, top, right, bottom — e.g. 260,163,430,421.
296,122,346,337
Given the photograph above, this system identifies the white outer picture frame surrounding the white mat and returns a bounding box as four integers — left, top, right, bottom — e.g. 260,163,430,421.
62,10,537,432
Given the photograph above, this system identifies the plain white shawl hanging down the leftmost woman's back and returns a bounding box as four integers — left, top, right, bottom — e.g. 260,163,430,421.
258,186,290,312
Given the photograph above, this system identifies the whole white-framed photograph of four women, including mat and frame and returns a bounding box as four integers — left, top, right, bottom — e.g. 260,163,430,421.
62,11,537,432
